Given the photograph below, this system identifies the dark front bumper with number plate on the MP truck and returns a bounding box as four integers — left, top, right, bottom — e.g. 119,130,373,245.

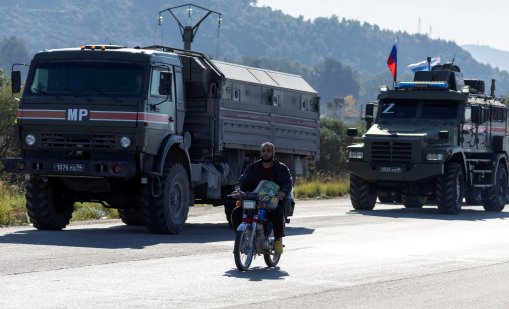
5,157,136,177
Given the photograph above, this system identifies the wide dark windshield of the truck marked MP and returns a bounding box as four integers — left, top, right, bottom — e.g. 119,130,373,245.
28,61,144,97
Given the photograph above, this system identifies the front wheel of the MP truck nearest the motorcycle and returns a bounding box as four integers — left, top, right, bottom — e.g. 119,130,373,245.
141,162,190,234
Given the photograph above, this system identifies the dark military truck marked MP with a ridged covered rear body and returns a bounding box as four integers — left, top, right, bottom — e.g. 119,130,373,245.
6,45,320,234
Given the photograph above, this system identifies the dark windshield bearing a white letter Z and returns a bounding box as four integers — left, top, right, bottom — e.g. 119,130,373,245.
380,100,458,120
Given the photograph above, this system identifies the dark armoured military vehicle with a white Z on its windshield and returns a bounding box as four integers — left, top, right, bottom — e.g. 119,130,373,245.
347,64,509,214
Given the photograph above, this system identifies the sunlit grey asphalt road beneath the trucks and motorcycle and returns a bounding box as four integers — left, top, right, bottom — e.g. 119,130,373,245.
0,198,509,308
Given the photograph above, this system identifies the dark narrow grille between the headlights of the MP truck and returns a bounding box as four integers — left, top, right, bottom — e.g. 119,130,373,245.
41,133,115,149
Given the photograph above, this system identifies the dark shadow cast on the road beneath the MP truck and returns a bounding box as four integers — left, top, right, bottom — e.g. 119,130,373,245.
0,223,313,249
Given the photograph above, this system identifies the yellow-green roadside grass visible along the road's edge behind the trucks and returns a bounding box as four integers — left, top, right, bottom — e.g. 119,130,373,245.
0,176,349,226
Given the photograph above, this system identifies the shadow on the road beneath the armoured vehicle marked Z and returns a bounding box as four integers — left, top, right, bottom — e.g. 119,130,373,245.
349,204,509,221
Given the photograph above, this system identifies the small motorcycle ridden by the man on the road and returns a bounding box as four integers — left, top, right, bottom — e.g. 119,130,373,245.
229,180,281,271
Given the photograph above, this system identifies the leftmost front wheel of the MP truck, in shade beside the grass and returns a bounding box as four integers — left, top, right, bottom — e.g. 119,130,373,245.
25,178,74,230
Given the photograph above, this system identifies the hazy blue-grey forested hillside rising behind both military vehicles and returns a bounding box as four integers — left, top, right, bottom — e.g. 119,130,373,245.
0,0,509,98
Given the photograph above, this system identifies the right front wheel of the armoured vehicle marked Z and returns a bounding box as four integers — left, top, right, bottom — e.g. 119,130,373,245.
435,162,465,214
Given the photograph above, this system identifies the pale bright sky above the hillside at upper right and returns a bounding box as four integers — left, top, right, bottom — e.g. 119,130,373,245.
257,0,509,51
